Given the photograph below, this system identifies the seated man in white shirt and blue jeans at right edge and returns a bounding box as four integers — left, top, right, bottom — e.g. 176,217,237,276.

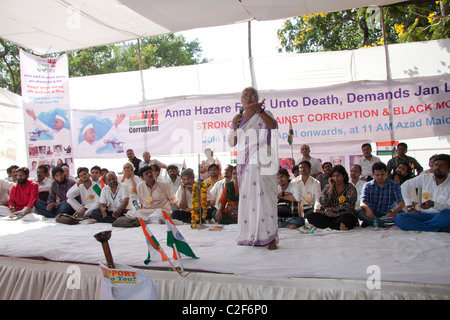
395,154,450,232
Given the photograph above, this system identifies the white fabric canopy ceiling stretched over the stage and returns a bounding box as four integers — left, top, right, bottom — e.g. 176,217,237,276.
0,0,402,54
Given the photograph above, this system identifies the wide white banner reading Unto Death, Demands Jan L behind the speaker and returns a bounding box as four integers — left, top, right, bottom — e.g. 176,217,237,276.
72,76,450,158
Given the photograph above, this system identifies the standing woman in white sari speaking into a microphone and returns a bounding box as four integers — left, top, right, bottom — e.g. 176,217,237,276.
229,88,279,250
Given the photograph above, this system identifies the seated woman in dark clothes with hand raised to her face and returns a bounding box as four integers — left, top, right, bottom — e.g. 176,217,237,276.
307,165,358,230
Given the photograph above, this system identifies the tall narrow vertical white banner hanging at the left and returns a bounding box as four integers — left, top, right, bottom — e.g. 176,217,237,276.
20,51,73,177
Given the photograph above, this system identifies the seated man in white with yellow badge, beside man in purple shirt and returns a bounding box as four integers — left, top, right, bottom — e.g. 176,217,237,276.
67,167,100,218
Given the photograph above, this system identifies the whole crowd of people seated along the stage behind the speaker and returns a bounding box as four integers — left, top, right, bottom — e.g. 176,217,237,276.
0,143,450,231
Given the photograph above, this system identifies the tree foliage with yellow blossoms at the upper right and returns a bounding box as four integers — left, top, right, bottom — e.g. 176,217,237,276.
278,0,450,52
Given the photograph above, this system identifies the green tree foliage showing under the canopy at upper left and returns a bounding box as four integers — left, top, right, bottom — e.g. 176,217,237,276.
0,34,208,94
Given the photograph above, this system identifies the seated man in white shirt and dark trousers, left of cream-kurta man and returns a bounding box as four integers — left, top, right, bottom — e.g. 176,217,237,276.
91,171,131,223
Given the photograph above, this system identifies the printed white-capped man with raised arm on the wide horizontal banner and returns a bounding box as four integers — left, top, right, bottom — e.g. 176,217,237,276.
78,113,125,155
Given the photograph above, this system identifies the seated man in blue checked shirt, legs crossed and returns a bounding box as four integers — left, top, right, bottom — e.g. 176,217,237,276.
358,162,405,227
